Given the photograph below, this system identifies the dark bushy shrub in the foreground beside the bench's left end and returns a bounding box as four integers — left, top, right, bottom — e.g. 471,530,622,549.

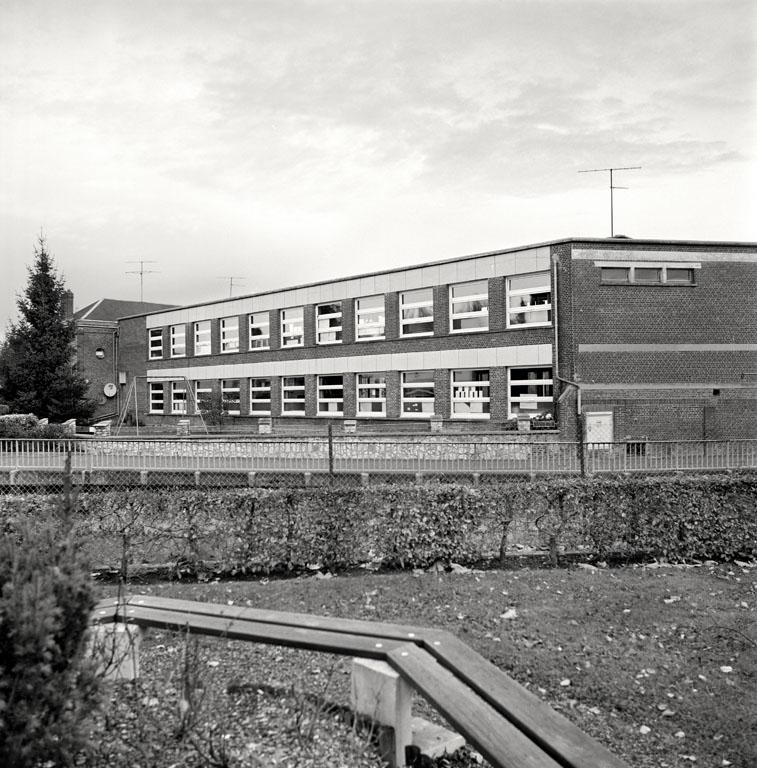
0,476,97,768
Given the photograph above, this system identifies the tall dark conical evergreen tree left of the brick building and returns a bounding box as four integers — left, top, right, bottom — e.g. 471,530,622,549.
0,237,96,422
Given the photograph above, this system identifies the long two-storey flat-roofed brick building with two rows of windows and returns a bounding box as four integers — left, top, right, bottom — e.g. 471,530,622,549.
108,238,757,442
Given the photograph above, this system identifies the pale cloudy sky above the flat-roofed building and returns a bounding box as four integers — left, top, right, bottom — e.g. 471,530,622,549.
0,0,757,332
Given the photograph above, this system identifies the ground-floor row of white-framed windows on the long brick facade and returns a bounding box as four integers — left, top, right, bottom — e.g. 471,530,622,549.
150,367,553,419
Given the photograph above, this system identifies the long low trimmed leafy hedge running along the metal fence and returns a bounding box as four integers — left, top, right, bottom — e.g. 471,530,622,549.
0,474,757,576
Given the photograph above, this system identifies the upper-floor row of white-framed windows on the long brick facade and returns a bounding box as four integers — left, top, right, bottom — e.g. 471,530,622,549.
149,271,552,360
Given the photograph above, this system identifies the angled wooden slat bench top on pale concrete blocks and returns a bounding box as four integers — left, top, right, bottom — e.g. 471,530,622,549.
93,595,628,768
